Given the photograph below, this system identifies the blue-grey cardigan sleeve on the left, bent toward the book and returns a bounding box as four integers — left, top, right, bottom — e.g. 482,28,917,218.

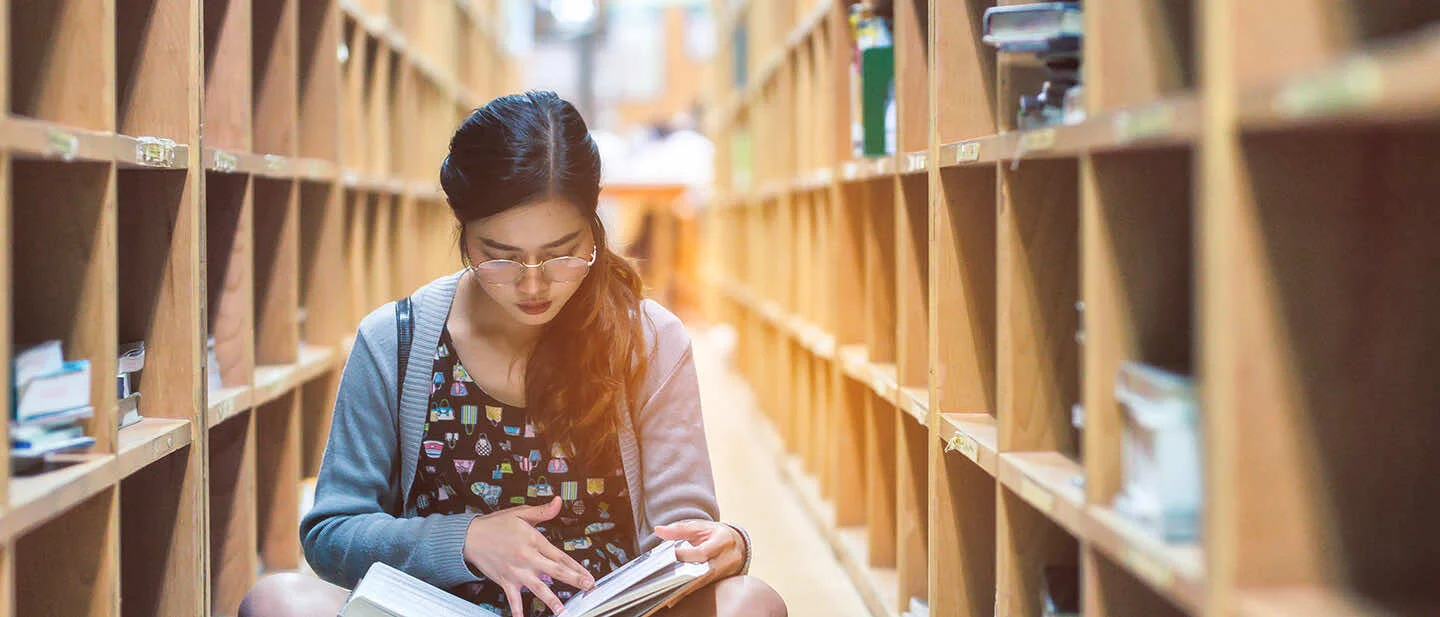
300,322,480,588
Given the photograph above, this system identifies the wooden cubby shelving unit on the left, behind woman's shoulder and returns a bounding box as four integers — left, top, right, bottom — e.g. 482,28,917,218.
0,0,513,617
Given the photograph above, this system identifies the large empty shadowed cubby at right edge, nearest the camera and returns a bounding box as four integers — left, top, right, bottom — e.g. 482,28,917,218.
1226,129,1440,601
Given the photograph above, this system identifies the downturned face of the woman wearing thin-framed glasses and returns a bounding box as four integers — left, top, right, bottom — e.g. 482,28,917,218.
464,199,595,326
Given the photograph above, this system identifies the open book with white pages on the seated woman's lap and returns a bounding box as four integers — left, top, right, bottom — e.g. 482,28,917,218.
340,541,710,617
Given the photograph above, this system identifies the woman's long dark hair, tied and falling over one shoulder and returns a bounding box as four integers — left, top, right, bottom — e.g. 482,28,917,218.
441,92,648,463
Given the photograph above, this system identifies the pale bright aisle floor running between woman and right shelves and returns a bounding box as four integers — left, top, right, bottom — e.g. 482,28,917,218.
691,327,870,617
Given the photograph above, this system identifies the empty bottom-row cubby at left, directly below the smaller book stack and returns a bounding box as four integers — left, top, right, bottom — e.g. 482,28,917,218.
120,446,204,617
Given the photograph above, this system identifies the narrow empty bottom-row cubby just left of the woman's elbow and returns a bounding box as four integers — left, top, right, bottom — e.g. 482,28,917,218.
255,391,302,572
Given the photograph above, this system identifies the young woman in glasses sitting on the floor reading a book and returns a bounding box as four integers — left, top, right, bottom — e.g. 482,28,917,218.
240,92,786,617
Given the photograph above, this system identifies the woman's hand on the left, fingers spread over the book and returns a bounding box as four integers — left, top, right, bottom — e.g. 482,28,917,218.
464,497,595,617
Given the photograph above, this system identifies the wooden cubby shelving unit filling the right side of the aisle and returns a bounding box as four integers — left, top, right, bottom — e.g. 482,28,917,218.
706,0,1440,617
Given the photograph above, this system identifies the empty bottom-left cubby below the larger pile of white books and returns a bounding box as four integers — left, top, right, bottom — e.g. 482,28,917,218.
12,487,120,616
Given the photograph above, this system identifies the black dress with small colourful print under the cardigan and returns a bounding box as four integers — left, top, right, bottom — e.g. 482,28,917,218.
410,329,635,617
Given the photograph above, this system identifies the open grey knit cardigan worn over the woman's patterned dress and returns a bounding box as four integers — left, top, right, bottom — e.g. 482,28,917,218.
300,271,720,588
